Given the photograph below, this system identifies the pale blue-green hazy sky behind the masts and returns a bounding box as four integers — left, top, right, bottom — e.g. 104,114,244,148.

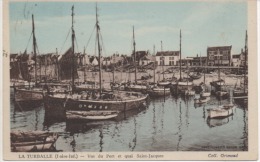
9,1,247,56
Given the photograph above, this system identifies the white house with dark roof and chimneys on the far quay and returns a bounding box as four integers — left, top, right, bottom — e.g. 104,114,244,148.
155,51,180,66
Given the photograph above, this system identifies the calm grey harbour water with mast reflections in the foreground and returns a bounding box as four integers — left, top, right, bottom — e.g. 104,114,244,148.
10,90,248,152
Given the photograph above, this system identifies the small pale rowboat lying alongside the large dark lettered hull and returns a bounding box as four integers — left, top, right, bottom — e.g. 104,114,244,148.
66,110,119,120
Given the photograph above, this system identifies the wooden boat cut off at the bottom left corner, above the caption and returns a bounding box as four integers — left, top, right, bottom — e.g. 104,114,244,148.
11,131,58,152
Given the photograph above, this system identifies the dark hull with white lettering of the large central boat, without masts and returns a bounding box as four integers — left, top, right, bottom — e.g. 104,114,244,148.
46,92,148,111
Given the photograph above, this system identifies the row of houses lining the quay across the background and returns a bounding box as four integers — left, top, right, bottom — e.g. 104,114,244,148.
10,46,248,67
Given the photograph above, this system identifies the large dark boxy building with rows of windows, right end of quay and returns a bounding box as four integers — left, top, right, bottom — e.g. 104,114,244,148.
207,46,232,66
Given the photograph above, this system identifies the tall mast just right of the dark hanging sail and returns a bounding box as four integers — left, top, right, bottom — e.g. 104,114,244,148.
71,5,75,93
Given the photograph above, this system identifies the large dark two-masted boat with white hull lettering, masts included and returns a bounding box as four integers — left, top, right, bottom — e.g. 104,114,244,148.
46,6,148,113
